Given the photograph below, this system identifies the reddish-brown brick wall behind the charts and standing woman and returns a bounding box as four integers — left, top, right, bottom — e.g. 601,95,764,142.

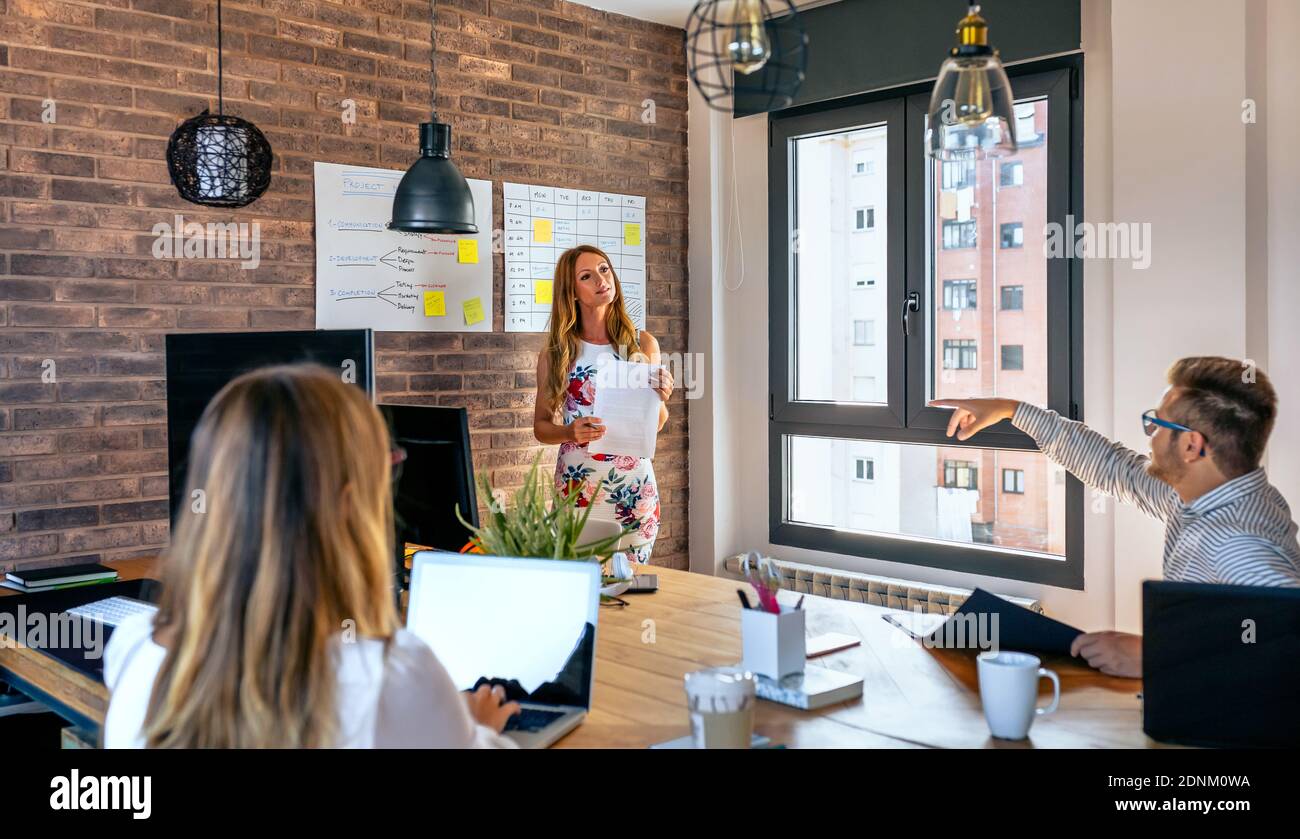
0,0,688,570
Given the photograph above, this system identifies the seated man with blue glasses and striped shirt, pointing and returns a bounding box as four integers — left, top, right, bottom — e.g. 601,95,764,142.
931,356,1300,678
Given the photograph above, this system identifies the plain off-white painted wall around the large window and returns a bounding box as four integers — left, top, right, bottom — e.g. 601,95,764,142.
690,0,1300,630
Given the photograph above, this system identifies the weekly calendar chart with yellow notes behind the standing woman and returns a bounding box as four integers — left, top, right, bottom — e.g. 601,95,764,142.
502,183,646,332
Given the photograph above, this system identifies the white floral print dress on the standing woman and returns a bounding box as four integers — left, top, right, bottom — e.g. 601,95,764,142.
555,341,659,562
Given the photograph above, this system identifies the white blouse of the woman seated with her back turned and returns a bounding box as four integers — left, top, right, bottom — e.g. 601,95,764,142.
104,615,515,749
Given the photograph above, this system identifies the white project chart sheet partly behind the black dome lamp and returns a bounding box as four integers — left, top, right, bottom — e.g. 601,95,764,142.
316,163,493,332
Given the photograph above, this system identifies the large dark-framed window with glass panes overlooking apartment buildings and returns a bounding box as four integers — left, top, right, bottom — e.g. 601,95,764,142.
768,59,1084,588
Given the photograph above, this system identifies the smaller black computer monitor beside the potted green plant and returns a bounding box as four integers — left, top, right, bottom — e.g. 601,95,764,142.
378,405,478,550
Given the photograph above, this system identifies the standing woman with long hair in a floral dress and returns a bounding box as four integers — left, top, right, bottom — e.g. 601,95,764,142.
533,245,673,562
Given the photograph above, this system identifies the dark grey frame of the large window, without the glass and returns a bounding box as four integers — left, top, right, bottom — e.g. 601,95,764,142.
768,55,1086,589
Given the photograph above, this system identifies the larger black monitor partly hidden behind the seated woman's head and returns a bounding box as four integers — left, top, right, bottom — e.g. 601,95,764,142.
166,329,374,522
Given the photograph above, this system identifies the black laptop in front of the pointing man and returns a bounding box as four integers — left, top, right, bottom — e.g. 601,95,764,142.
1143,581,1300,747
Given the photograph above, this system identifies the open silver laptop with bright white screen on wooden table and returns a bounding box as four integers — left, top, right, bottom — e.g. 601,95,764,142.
407,550,601,748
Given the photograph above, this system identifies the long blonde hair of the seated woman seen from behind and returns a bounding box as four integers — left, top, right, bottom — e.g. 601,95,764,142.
144,366,398,748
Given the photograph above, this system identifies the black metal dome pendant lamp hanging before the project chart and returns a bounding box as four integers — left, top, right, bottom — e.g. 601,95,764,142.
389,0,478,233
